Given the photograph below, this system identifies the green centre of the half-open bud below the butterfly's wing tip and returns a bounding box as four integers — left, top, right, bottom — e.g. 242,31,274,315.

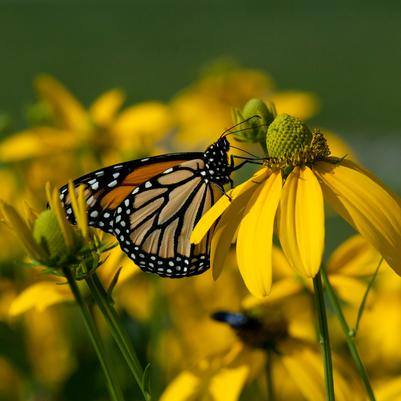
33,210,68,258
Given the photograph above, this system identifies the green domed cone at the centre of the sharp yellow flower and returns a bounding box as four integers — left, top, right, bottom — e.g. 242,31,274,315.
266,114,313,158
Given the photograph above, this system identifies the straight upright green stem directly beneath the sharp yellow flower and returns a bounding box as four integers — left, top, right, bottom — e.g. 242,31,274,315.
313,272,335,401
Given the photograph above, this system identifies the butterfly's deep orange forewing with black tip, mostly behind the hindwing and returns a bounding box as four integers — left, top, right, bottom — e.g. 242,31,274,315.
60,152,202,233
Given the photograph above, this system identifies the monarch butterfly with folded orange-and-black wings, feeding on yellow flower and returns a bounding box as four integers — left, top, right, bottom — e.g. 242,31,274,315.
60,126,256,278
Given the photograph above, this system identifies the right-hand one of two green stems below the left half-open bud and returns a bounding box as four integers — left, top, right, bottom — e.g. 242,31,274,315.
86,273,151,401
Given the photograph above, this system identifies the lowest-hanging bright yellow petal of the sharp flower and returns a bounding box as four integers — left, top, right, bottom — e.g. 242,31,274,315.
237,172,282,297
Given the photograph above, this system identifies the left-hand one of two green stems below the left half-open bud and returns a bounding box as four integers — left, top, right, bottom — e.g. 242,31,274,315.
63,268,124,401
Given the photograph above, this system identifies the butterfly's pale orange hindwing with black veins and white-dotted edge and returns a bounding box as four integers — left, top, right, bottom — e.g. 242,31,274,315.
112,157,222,277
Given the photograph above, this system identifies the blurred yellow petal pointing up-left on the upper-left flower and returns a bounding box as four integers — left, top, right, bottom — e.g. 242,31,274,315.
35,75,89,132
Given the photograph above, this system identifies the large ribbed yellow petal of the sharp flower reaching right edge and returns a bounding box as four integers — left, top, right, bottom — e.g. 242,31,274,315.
314,161,401,275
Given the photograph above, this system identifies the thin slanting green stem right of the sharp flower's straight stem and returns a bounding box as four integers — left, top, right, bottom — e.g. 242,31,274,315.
321,269,375,401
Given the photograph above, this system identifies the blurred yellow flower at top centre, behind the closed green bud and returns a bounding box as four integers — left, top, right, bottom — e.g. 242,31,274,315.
171,64,318,150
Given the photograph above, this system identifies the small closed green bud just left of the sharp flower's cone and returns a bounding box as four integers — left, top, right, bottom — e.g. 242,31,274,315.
234,98,275,142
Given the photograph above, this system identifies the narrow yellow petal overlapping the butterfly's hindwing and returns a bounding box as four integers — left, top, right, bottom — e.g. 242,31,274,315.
191,168,268,244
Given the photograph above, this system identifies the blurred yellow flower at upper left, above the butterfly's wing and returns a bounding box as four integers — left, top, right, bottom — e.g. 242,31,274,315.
0,75,172,162
